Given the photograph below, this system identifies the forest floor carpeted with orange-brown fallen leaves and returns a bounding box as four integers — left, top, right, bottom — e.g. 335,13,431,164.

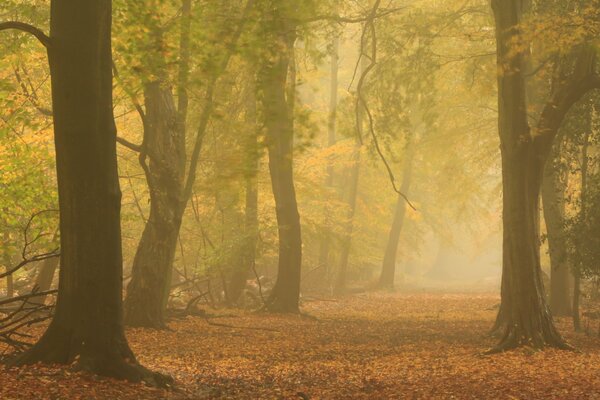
0,293,600,400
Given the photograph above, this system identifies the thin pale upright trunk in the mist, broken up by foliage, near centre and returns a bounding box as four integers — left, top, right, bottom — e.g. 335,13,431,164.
319,37,340,276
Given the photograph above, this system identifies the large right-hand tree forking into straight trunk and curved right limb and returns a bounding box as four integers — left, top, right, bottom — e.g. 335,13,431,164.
490,0,600,352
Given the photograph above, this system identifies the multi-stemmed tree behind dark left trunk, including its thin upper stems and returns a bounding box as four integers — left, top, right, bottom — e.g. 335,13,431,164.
121,0,253,328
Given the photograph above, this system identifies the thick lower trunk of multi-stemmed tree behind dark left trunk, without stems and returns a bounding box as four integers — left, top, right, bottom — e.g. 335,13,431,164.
124,82,185,328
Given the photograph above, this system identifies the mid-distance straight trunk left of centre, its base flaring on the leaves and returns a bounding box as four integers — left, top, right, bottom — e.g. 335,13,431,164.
259,8,302,313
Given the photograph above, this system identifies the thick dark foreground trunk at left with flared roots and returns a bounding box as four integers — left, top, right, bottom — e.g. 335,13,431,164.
16,0,166,383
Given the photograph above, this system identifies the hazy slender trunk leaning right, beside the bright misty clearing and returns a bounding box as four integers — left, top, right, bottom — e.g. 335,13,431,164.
377,149,414,289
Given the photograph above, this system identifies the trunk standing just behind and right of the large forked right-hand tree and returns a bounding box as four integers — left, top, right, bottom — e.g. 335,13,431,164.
542,146,572,317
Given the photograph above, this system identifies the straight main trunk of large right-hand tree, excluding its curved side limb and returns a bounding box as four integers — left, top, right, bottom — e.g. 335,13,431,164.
492,0,567,351
